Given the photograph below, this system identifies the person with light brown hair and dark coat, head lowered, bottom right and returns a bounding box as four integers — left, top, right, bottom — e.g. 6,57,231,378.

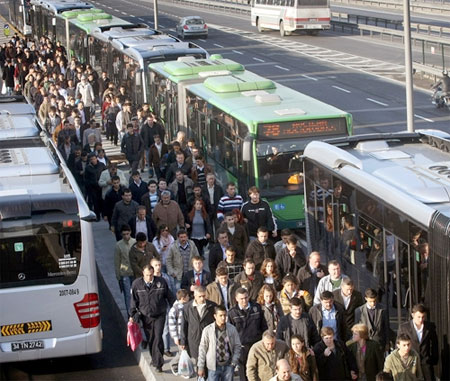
347,324,384,381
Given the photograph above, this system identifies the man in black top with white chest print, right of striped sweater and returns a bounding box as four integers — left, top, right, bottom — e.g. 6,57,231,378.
241,187,277,237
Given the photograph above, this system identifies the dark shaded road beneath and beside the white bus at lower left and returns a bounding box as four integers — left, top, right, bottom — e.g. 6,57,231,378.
0,274,145,381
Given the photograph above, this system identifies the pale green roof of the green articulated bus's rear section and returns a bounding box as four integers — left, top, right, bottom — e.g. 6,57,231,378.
150,54,245,83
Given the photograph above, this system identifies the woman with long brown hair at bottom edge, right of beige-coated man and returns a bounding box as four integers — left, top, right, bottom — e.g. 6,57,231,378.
288,335,319,381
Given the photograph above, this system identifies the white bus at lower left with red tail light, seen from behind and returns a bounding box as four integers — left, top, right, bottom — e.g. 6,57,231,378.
0,97,102,363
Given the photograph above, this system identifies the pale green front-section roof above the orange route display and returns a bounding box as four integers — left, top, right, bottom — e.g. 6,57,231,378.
188,71,350,134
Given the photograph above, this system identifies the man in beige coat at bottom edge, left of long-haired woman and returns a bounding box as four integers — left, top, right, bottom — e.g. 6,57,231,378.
247,330,289,381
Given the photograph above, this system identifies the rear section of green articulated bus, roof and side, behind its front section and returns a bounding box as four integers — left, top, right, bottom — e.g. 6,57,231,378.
147,54,245,139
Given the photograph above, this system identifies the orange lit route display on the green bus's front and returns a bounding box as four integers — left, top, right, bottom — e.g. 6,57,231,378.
258,118,347,140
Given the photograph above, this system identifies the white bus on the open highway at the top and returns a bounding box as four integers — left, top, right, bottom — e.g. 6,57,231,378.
251,0,331,37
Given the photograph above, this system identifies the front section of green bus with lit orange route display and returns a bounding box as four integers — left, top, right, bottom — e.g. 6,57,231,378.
185,71,352,229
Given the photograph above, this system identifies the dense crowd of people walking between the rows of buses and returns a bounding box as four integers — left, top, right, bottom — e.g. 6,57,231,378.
0,36,438,381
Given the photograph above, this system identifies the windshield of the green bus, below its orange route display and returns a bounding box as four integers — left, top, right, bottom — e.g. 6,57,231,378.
256,139,308,197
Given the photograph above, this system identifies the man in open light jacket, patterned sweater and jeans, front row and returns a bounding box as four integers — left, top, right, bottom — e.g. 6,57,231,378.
197,306,241,381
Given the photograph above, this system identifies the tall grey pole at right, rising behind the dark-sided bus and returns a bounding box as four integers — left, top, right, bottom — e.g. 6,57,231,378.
404,0,414,132
